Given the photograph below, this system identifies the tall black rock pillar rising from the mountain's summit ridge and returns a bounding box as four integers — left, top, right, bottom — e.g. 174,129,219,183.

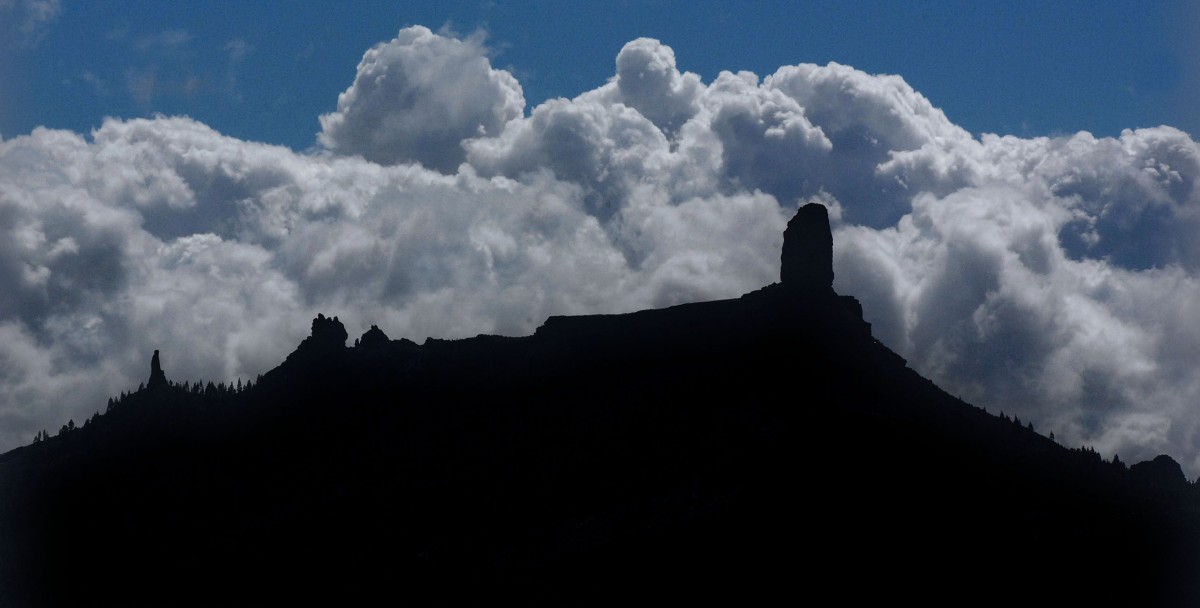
779,203,833,293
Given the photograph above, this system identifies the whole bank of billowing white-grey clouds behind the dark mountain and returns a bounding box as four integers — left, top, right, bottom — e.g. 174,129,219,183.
0,26,1200,475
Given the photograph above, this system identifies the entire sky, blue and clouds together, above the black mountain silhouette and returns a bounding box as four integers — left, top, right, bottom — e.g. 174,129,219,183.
0,0,1200,477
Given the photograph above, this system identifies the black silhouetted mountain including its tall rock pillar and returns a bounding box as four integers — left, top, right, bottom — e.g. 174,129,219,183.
0,205,1200,606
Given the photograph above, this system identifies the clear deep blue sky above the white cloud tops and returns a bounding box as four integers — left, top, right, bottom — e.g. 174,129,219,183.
0,0,1200,150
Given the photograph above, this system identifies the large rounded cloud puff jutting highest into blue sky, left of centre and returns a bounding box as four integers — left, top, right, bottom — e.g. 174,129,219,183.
319,25,524,173
